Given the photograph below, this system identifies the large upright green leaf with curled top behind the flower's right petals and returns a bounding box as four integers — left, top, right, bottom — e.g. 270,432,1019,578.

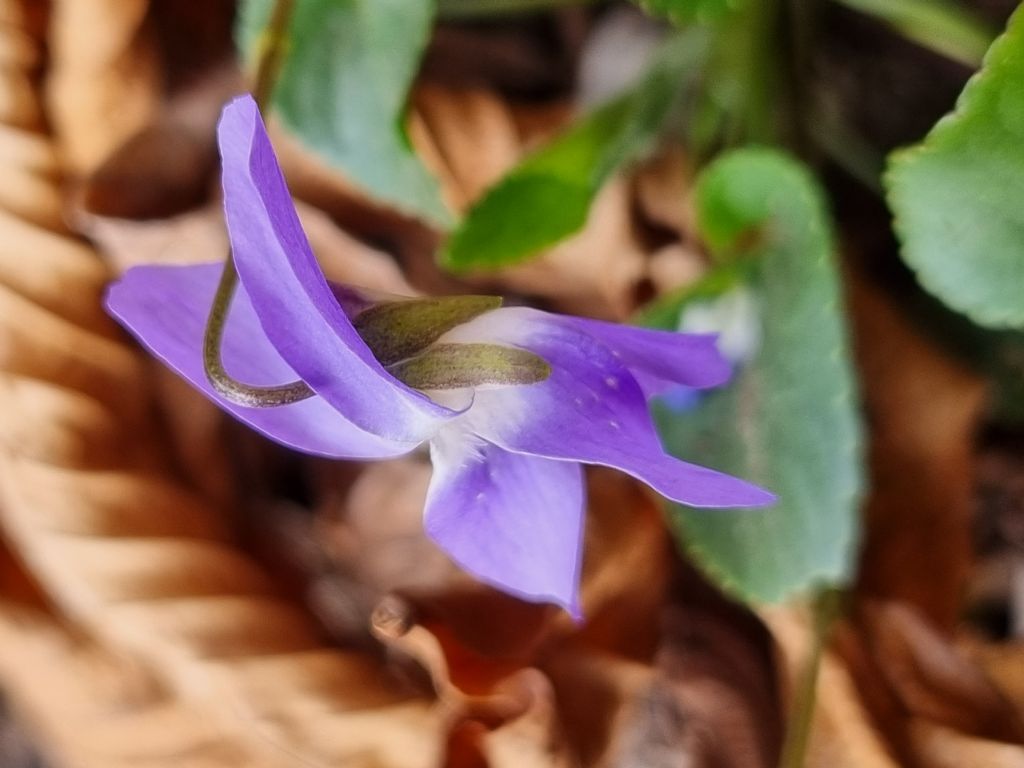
655,150,861,602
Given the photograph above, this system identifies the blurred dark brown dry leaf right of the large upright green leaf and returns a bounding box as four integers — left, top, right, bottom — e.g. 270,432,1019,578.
851,273,985,630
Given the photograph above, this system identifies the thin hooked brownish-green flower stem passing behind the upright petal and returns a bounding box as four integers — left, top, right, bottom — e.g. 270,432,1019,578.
203,0,313,408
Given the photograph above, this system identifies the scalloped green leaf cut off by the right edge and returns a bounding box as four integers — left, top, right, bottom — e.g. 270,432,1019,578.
885,8,1024,328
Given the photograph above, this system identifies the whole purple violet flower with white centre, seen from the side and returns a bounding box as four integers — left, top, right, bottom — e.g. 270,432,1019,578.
106,96,774,616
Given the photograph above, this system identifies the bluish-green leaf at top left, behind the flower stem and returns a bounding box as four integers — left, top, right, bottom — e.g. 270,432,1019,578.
239,0,451,224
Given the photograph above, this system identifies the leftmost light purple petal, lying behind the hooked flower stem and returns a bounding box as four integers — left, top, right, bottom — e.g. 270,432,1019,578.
106,263,417,459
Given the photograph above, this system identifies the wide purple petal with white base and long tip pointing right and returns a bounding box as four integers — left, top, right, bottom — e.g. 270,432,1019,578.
444,307,774,507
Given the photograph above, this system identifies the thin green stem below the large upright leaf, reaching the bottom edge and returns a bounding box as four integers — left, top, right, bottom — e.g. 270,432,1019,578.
778,588,843,768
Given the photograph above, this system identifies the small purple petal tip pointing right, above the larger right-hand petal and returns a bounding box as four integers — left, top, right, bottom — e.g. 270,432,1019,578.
552,315,731,396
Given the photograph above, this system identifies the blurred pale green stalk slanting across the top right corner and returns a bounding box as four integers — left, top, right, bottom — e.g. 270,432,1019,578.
836,0,995,69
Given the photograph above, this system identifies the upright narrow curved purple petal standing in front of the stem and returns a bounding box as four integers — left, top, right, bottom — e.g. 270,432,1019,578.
218,96,455,441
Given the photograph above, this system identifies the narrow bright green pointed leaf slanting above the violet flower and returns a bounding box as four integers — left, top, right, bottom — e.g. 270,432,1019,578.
441,33,705,271
